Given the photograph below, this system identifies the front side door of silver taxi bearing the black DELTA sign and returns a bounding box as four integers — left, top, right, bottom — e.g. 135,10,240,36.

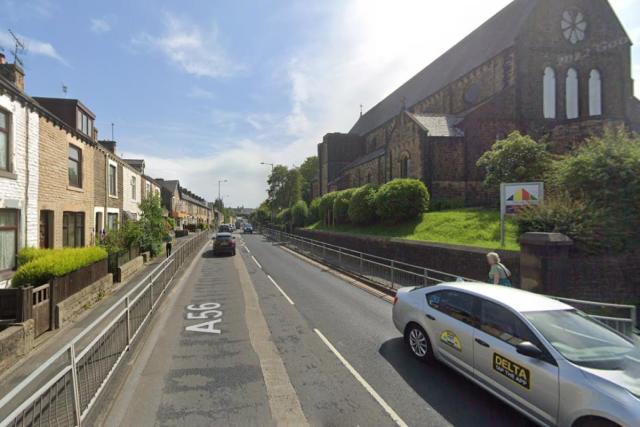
474,299,559,424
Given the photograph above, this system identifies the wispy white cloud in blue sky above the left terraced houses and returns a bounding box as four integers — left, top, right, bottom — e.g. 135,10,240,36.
132,13,241,78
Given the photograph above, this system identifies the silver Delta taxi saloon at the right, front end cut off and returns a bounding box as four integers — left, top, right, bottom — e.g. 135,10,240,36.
393,282,640,427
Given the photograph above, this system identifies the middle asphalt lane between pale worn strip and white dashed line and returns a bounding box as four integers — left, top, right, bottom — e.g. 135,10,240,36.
238,239,395,426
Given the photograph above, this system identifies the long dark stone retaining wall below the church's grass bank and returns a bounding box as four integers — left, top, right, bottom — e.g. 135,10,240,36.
295,229,520,284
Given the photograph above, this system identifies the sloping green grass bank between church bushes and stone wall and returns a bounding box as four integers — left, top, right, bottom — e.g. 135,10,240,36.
307,208,520,251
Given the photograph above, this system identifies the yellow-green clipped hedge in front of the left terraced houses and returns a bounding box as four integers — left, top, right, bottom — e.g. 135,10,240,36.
11,247,107,287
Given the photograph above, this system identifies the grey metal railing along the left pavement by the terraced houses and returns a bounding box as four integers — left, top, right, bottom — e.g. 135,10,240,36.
0,232,209,427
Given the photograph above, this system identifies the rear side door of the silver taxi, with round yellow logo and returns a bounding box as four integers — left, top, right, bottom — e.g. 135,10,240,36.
426,290,475,376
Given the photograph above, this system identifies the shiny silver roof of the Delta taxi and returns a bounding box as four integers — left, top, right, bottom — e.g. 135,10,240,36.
440,282,573,313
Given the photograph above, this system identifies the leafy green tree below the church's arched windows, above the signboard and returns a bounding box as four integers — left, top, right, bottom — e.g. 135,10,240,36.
476,131,551,187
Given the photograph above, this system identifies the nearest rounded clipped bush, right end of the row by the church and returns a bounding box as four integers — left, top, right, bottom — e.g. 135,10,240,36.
375,179,429,223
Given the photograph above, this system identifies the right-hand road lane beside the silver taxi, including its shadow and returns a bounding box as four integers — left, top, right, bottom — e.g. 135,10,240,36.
240,236,528,426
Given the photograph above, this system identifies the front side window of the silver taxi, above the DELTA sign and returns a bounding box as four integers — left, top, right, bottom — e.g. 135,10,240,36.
480,300,543,349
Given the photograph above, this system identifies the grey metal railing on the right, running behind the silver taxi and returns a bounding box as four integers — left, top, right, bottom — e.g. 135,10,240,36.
261,228,637,336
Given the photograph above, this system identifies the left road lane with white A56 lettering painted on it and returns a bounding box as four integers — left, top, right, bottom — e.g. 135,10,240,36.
107,244,272,426
